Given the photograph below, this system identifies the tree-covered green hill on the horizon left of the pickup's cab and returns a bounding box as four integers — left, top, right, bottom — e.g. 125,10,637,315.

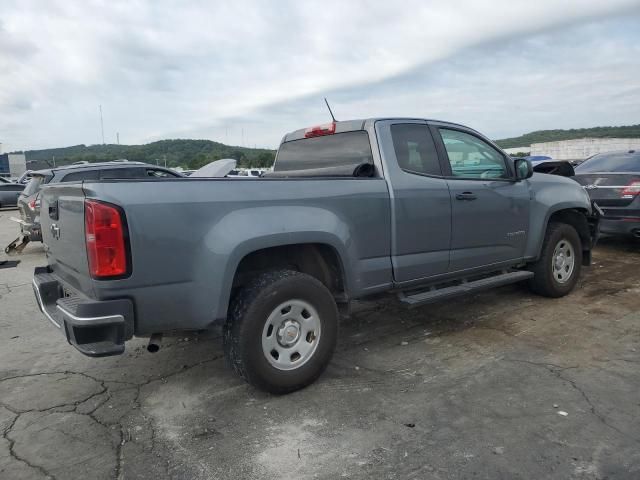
15,140,275,170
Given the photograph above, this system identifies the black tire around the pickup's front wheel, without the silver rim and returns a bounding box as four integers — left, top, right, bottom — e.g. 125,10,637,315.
529,222,582,298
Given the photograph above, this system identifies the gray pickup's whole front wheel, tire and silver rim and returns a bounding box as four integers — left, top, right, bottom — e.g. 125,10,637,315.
529,223,582,298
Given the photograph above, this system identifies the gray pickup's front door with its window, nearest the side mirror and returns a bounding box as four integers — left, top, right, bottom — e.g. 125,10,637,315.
432,125,531,272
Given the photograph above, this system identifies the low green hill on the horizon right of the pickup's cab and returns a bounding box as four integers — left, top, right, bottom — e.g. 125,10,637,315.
496,125,640,148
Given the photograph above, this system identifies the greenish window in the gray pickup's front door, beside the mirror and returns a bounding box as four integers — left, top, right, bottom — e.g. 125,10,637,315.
439,128,510,179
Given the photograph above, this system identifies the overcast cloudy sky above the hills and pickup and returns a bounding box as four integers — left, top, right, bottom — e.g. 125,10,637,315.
0,0,640,151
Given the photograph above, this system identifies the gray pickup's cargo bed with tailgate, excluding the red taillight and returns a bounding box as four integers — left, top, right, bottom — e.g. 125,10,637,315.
42,178,392,335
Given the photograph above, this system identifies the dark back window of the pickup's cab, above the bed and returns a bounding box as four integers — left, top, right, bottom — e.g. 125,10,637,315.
274,130,373,172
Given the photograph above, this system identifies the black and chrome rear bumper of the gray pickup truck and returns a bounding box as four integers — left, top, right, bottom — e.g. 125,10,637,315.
33,267,134,357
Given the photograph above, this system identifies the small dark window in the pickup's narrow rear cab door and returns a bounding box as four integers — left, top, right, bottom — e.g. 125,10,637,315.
391,123,442,175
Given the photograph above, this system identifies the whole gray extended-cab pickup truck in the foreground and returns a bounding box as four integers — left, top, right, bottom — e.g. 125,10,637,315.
33,118,598,393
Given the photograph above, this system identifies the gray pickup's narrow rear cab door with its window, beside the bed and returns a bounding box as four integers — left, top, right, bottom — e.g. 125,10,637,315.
376,120,451,282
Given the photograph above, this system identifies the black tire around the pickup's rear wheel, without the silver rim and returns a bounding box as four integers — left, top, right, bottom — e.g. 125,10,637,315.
224,270,338,394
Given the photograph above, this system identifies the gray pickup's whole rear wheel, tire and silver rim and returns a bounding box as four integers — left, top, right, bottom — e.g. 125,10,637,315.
224,270,338,394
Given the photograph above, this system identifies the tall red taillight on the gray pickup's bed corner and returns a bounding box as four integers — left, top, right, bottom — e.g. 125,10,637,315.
84,200,128,278
